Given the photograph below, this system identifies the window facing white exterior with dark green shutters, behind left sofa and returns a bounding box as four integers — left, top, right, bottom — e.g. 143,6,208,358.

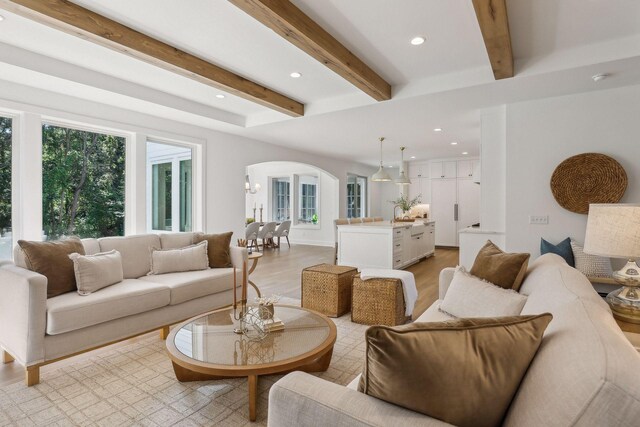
147,141,193,231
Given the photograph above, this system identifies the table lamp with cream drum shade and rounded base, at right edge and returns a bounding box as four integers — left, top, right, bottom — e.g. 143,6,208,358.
584,203,640,324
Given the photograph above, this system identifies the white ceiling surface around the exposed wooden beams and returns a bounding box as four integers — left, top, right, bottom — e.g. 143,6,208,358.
0,0,640,164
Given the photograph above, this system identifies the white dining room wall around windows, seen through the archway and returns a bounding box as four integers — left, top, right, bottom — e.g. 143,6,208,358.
245,162,338,246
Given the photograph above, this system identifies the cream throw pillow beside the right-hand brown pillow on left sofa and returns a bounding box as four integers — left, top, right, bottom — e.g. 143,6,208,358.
148,240,209,276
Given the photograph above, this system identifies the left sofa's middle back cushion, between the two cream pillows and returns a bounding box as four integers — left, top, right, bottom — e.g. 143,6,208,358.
98,234,160,279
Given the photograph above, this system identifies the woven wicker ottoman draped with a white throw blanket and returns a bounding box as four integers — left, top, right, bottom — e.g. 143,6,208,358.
351,275,409,326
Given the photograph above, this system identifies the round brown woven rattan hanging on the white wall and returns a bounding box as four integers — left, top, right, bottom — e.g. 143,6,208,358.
551,153,627,214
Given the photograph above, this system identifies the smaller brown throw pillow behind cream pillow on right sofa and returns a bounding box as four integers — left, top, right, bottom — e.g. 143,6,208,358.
470,240,531,291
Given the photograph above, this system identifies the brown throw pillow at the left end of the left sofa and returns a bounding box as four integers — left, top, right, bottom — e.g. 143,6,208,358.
18,237,84,298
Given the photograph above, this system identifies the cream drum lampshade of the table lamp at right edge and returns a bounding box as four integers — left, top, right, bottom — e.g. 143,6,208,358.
584,203,640,259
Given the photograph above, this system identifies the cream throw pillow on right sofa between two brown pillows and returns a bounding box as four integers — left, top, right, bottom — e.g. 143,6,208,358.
440,267,527,318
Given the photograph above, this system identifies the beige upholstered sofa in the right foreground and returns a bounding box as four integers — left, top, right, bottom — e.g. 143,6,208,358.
269,254,640,427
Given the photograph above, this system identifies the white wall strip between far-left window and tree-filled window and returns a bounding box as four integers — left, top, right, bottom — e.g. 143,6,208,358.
11,113,43,241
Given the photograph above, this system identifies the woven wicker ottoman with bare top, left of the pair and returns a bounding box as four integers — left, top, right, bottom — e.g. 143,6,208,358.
302,264,358,317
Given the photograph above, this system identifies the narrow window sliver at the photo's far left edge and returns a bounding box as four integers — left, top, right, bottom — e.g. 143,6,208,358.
0,117,13,259
